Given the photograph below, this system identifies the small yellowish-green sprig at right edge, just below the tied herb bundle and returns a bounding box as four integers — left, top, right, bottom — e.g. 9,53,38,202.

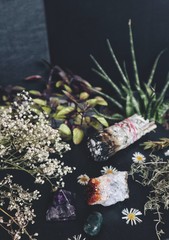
141,138,169,150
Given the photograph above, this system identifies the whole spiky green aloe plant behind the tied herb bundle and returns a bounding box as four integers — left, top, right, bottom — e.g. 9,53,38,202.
91,20,169,123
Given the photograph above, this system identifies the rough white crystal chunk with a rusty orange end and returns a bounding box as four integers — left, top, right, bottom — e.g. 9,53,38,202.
87,172,129,206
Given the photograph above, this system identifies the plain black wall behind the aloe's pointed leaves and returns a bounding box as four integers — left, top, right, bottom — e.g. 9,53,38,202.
45,0,169,92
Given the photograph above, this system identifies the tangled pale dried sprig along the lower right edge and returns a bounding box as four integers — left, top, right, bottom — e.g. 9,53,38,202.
130,154,169,240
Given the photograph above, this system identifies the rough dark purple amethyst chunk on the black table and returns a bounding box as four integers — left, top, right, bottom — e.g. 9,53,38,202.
46,189,76,221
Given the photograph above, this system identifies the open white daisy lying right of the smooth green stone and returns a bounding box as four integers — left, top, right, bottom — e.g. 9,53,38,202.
122,208,142,226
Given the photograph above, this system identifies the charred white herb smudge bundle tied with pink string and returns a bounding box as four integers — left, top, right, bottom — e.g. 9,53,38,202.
88,114,157,161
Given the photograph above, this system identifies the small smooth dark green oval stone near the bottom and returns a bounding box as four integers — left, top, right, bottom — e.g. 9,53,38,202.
83,212,103,236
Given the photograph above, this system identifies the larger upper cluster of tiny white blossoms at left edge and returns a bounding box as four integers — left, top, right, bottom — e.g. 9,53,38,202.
0,92,73,187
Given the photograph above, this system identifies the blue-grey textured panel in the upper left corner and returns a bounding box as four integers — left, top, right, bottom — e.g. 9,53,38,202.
0,0,49,85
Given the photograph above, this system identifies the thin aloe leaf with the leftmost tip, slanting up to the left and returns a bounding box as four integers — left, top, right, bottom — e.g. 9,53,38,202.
90,55,121,96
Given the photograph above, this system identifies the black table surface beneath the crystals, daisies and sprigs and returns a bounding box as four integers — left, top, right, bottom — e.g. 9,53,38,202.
0,123,169,240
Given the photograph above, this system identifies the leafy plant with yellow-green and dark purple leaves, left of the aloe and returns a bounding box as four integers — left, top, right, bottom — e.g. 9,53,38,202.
2,66,116,144
